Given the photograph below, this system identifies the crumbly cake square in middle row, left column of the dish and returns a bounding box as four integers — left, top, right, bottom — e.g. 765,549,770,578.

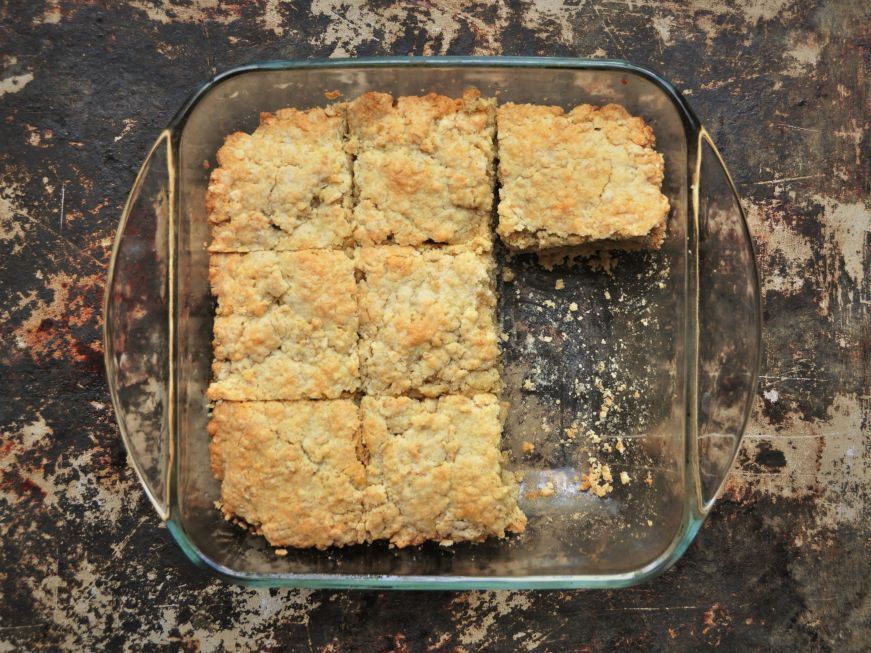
208,250,360,401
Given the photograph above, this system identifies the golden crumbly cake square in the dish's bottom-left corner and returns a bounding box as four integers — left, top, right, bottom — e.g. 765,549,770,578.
209,400,366,549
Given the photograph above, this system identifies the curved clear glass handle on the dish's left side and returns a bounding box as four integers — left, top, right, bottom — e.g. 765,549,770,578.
103,131,175,519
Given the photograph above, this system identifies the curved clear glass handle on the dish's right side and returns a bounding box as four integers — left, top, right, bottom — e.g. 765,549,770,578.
693,129,762,512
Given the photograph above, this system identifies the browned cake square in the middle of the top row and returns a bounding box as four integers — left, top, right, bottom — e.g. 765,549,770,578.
348,89,495,245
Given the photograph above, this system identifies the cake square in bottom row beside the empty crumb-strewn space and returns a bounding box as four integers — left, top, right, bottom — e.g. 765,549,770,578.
361,394,526,547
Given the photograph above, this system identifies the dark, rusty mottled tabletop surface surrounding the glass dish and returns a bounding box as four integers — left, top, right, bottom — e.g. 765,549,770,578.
0,0,871,652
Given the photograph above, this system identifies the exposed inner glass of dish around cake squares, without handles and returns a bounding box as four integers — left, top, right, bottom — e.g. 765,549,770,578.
174,66,688,578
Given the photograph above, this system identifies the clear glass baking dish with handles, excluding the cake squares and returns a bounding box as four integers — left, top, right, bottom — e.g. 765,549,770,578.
104,57,761,589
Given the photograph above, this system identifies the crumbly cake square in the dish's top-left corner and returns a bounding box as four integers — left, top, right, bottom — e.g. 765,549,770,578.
206,105,352,252
